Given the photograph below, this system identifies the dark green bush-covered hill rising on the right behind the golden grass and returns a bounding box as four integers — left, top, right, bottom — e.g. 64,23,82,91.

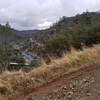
45,12,100,54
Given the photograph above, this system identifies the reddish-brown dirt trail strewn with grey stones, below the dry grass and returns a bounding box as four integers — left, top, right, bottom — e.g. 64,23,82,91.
20,63,100,100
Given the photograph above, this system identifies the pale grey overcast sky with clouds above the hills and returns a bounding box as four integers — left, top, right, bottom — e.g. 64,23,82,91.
0,0,100,30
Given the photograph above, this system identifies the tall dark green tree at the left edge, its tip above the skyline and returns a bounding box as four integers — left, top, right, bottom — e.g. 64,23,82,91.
0,22,12,70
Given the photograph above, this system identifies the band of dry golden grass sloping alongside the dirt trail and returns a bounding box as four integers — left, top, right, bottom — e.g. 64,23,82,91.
0,45,100,100
